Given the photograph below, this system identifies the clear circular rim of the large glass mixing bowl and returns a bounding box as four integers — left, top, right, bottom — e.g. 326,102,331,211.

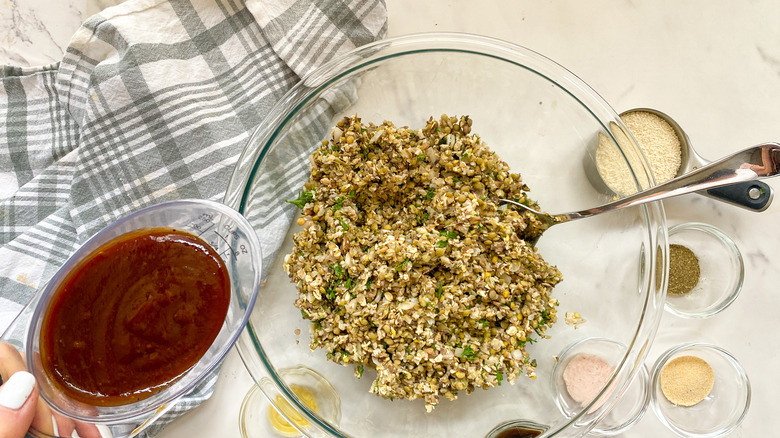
224,32,668,437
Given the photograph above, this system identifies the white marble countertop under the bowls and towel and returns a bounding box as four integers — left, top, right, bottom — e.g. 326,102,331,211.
0,0,780,438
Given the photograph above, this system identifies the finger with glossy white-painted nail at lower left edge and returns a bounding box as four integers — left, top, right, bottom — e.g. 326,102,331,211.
0,371,38,438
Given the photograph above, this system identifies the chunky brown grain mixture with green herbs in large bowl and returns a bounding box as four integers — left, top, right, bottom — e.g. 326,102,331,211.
284,115,561,412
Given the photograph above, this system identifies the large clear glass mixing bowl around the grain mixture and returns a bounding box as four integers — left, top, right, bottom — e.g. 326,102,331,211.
225,33,668,437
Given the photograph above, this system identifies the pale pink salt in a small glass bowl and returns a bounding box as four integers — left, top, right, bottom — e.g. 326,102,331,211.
563,354,615,409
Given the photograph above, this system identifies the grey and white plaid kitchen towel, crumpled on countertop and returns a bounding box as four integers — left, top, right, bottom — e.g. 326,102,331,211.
0,0,387,436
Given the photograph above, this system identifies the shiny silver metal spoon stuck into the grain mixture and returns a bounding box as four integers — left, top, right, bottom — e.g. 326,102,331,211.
499,143,780,240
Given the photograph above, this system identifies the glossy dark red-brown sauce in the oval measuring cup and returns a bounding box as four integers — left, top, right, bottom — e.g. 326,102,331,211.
41,228,230,406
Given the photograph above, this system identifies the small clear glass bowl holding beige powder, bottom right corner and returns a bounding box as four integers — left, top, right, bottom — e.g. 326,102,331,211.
650,343,750,438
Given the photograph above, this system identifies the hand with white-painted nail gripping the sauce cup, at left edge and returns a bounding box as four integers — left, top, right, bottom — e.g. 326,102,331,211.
0,343,38,438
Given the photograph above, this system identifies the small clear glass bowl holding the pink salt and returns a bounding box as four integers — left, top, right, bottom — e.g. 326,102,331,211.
551,338,650,436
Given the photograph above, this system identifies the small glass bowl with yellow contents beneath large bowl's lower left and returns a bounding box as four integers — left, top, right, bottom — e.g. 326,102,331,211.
238,366,341,438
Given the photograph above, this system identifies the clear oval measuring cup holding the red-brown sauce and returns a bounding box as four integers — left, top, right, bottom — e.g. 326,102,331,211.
3,199,262,438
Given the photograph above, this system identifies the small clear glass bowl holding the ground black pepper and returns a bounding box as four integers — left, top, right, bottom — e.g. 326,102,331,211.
666,222,745,318
